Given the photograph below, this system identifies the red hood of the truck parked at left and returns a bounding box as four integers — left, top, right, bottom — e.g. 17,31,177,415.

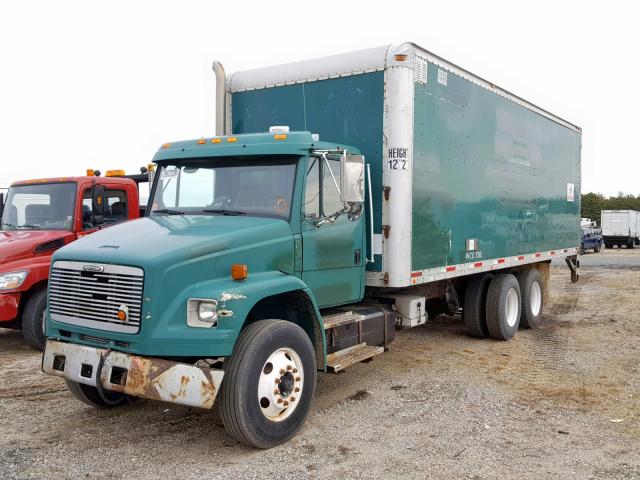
0,230,75,269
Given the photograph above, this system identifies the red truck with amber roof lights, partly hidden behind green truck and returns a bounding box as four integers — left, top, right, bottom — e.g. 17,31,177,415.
0,168,152,350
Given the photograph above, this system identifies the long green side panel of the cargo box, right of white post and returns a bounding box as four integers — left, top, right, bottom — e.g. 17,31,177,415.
412,62,580,271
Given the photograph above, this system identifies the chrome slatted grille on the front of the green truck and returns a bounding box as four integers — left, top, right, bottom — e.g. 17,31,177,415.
48,260,144,333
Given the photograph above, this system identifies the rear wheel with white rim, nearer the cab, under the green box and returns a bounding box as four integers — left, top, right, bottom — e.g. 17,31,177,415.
487,273,522,340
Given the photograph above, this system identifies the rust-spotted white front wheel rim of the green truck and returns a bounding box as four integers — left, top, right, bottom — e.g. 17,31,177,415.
258,348,304,422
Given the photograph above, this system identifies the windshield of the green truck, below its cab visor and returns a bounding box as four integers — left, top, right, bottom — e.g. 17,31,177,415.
151,157,297,220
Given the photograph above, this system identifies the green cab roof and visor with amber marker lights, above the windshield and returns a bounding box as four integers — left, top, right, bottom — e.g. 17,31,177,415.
153,132,360,164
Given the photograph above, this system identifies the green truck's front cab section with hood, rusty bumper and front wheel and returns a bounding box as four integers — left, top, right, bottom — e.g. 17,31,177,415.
43,132,376,446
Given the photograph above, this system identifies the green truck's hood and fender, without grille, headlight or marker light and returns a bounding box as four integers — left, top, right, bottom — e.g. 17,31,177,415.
47,215,304,356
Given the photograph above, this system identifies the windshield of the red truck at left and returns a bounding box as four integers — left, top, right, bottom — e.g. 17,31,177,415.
1,183,76,230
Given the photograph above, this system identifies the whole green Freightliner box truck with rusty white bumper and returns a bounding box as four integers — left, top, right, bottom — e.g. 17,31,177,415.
43,43,581,448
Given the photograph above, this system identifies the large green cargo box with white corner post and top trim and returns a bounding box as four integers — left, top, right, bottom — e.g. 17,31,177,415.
227,44,581,287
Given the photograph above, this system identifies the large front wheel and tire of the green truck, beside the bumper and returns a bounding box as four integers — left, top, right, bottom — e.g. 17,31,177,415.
219,320,316,448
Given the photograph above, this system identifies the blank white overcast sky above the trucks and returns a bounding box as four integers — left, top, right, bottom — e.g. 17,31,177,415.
0,0,640,194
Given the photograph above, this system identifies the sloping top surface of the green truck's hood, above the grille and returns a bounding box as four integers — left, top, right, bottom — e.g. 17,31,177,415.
54,215,292,268
